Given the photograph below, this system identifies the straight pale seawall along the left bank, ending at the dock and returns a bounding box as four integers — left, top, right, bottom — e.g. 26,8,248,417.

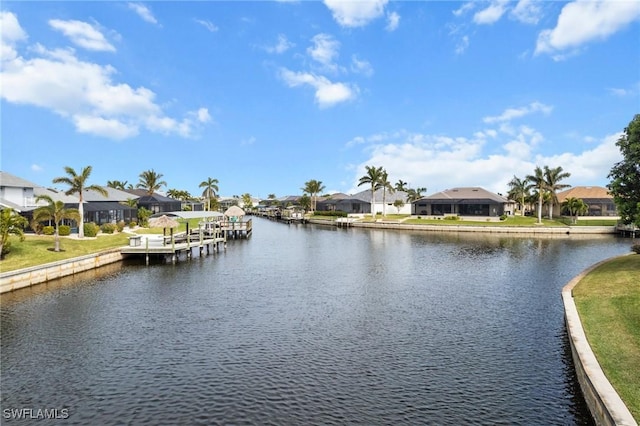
0,248,123,294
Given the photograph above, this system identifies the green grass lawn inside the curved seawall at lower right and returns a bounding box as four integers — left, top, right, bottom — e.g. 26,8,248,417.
573,254,640,422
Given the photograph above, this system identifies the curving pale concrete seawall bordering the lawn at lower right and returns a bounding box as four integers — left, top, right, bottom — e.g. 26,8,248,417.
562,259,637,426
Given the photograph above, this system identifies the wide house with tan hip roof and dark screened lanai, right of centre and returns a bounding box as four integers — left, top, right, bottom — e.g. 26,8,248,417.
411,187,515,217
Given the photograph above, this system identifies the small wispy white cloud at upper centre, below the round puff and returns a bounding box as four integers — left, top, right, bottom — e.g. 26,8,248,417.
280,68,358,108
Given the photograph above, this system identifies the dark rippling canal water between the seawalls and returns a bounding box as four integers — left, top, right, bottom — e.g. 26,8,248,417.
1,218,631,425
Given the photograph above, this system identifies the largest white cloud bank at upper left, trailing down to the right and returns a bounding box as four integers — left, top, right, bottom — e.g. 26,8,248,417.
0,15,210,139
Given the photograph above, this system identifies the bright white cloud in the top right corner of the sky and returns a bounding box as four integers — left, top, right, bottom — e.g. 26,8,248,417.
535,0,640,54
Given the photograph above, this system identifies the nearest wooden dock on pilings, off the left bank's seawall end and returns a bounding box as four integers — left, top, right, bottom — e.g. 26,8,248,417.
120,228,227,265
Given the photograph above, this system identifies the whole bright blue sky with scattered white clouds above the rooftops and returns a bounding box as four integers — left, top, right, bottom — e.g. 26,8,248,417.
0,0,640,198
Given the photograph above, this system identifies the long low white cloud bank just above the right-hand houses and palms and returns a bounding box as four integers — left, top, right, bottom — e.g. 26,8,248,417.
347,126,620,194
